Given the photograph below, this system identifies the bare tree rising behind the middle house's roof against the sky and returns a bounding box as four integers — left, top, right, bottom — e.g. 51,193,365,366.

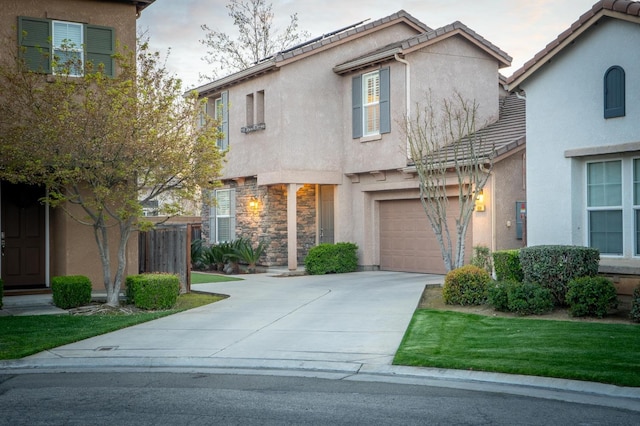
200,0,309,80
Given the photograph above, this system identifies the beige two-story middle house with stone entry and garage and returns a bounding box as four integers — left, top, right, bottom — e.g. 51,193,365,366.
196,10,524,273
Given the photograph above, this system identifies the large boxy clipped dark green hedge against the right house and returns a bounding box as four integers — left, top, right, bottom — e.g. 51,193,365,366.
520,246,600,306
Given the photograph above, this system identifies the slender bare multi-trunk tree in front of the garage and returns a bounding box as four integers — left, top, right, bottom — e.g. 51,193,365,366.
404,93,494,271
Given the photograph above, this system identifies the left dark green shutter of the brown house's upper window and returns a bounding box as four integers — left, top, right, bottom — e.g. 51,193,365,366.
18,16,51,74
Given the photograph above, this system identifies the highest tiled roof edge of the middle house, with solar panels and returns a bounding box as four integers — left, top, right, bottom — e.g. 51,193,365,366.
195,10,431,95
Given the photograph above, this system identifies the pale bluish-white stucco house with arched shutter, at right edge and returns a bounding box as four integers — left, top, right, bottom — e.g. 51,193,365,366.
508,0,640,293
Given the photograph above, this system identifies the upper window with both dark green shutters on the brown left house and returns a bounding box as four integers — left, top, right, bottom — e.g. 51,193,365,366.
18,16,115,76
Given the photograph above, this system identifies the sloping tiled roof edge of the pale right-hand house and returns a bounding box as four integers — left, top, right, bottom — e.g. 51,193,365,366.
507,0,640,89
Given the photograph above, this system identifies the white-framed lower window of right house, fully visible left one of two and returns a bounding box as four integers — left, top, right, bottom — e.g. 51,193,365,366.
587,160,624,256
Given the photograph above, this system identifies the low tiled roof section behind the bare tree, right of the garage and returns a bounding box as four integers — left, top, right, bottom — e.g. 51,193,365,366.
410,93,526,170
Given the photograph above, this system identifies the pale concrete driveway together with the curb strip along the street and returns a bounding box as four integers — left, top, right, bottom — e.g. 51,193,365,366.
0,272,640,411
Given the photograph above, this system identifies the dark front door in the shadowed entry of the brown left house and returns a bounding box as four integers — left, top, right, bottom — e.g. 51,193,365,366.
0,182,46,289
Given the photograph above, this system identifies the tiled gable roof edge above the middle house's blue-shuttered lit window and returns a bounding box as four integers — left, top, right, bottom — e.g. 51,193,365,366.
333,21,511,74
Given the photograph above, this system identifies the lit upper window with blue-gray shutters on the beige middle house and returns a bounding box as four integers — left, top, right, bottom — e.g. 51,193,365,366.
351,68,391,138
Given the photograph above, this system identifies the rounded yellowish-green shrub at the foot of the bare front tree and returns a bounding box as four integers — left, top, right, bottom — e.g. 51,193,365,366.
442,265,491,305
